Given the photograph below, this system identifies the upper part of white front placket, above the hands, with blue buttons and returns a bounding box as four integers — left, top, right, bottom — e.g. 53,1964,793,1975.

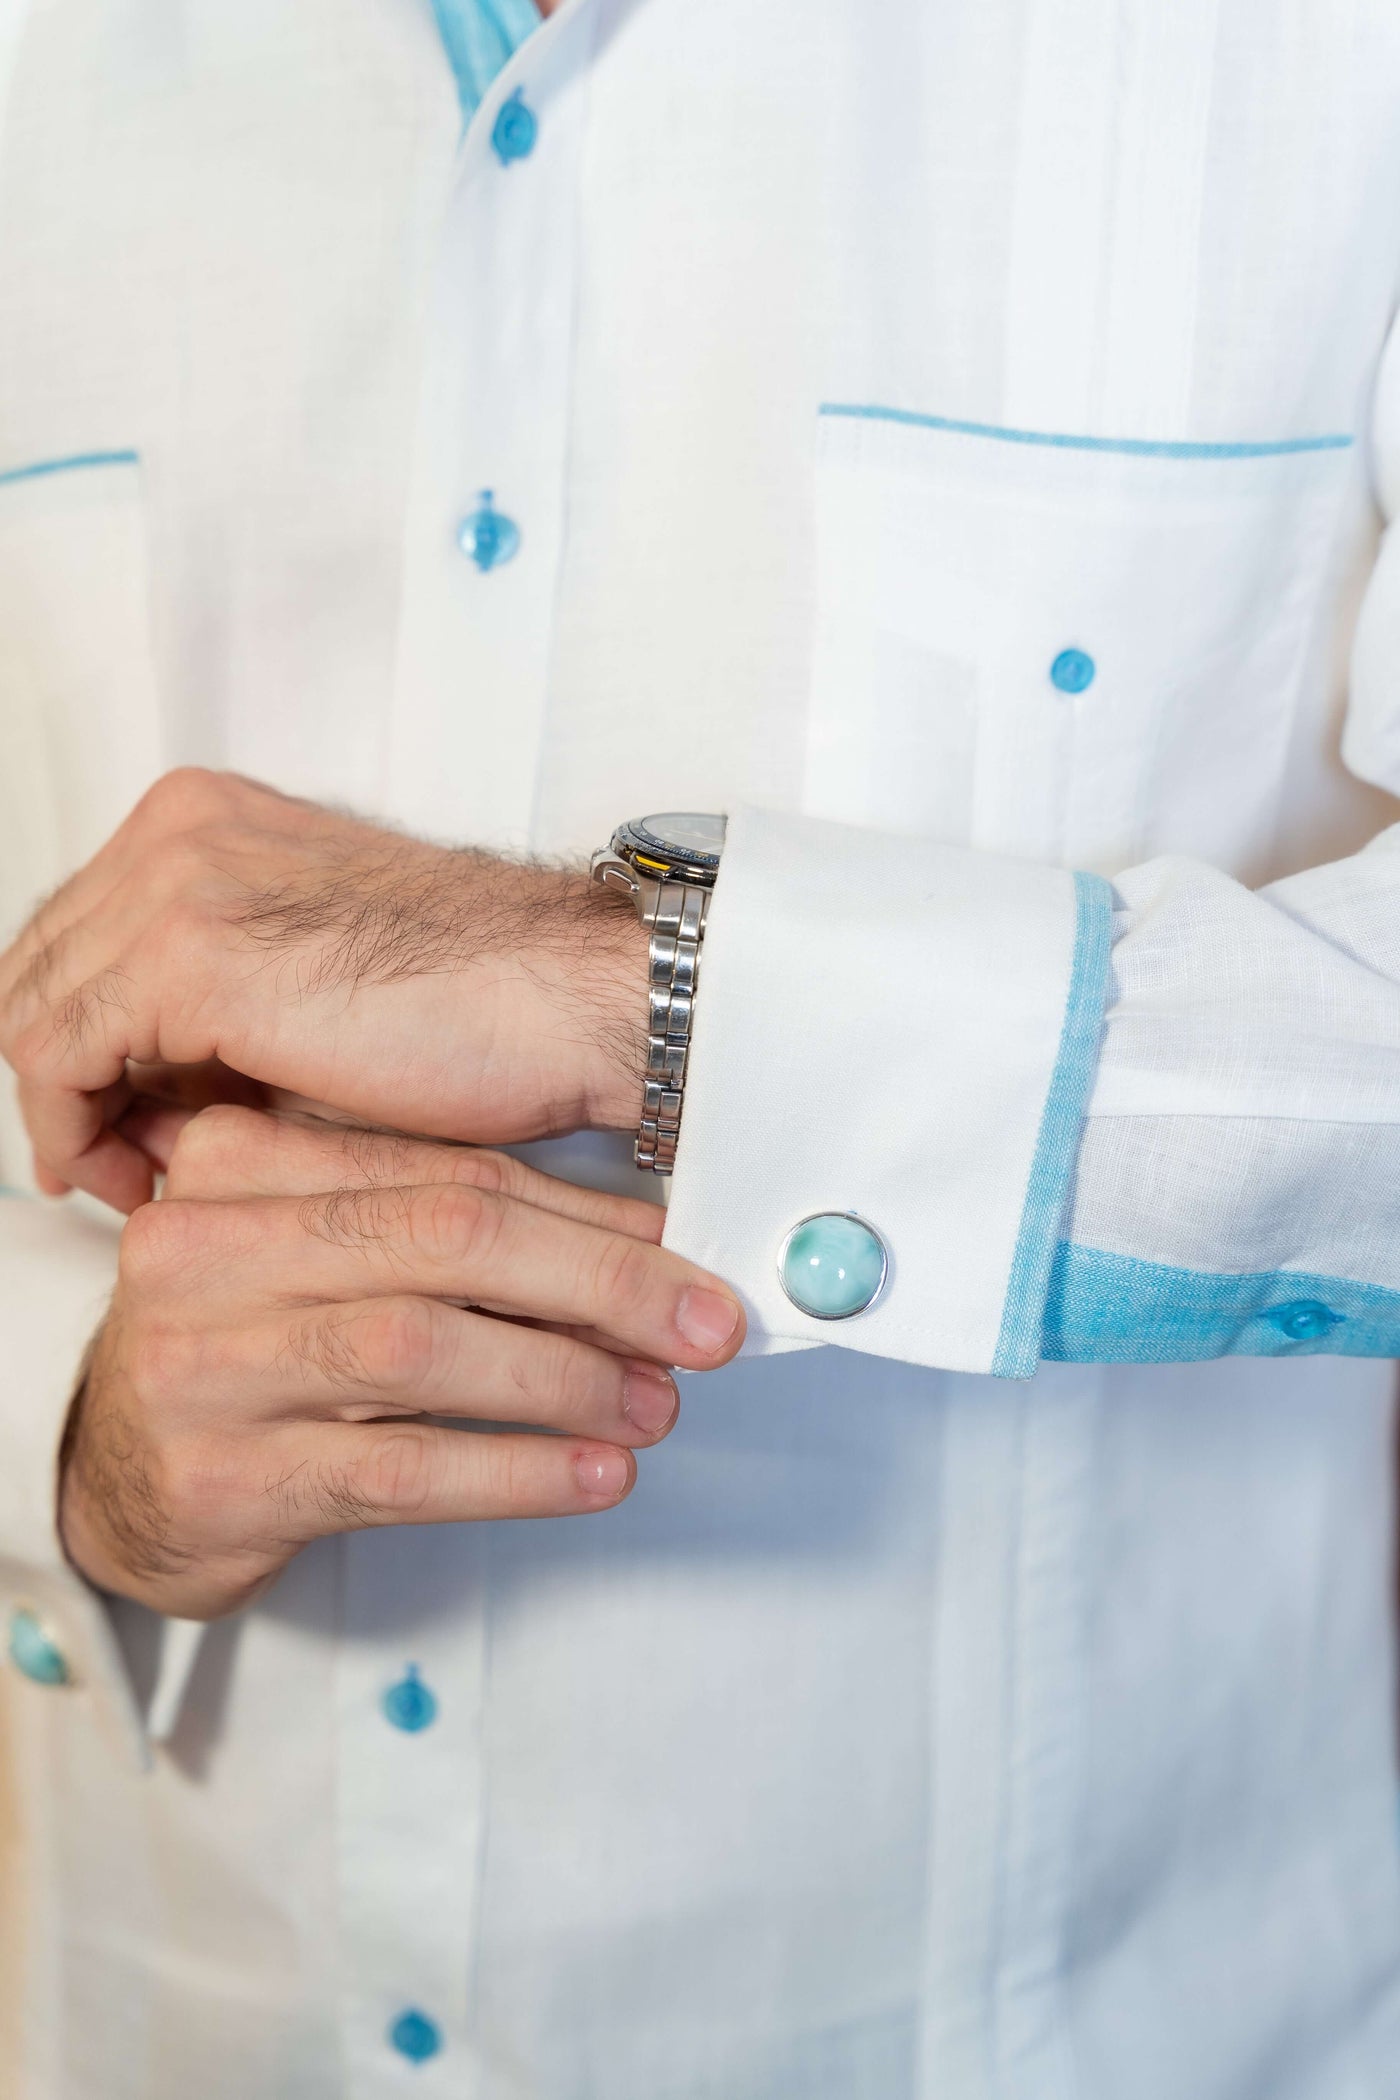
386,0,594,848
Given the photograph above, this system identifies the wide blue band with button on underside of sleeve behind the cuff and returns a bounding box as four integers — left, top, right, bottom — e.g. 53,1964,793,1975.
1041,1241,1400,1363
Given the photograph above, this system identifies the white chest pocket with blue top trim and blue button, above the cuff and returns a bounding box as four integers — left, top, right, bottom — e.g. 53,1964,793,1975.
804,410,1356,874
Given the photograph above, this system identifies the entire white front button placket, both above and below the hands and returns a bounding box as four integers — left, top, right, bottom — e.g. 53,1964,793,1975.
336,0,594,2100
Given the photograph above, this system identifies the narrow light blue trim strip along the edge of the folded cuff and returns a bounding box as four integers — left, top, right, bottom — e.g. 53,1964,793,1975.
991,874,1112,1378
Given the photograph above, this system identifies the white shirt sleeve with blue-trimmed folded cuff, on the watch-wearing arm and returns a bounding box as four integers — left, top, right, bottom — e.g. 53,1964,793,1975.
667,331,1400,1376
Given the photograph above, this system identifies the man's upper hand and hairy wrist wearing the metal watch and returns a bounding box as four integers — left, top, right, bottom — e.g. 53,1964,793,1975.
0,771,646,1212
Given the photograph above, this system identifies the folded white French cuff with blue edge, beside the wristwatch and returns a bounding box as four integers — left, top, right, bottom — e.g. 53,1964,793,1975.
665,809,1112,1378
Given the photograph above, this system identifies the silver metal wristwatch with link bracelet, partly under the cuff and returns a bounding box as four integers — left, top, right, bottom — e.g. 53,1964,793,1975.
590,815,724,1174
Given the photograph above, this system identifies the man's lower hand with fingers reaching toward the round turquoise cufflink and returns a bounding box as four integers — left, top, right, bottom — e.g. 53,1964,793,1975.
61,1107,743,1619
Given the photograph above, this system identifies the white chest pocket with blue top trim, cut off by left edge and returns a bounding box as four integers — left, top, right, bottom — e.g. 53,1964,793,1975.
0,454,164,1182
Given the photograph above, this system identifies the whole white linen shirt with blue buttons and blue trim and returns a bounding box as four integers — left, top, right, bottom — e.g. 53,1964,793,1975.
0,0,1400,2100
